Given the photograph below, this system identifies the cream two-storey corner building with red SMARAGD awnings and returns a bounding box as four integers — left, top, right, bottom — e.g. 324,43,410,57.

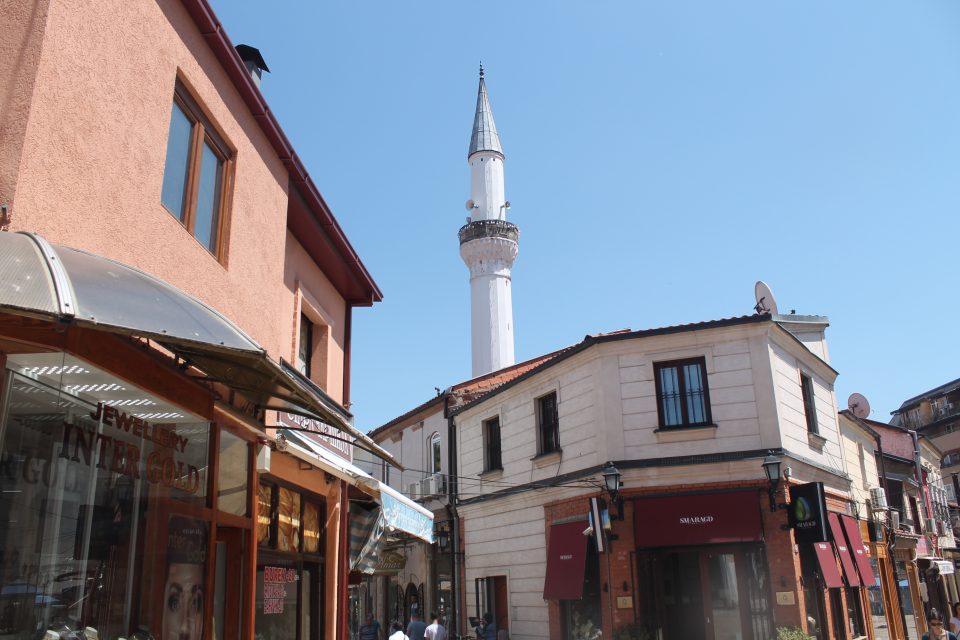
452,315,876,639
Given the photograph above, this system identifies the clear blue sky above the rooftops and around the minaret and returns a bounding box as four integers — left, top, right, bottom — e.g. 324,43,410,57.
213,0,960,430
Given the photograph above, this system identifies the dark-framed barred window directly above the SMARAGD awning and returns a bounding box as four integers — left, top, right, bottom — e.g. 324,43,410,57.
653,358,713,429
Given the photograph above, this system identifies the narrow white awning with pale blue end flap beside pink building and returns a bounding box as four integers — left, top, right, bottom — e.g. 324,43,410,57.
281,429,433,544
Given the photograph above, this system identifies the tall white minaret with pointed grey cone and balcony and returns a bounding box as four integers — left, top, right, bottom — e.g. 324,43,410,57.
460,65,520,377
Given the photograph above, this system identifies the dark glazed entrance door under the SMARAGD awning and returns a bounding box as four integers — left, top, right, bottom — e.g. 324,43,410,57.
655,547,763,640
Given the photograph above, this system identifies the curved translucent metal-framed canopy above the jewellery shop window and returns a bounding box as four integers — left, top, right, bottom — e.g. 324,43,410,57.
0,232,396,464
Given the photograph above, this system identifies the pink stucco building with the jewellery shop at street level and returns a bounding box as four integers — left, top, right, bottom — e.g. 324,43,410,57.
0,0,429,640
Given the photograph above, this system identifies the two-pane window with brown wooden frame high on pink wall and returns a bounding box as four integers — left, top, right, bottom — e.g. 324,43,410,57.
160,82,233,258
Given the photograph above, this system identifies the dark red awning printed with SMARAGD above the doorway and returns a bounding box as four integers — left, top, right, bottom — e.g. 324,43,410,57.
633,491,763,547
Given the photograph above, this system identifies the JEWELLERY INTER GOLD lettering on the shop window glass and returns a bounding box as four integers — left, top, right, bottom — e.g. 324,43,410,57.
23,403,201,493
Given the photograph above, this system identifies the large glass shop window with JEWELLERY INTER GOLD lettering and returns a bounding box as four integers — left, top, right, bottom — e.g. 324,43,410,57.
0,353,211,640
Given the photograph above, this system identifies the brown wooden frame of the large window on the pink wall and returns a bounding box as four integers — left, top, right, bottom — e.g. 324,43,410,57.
160,80,236,262
